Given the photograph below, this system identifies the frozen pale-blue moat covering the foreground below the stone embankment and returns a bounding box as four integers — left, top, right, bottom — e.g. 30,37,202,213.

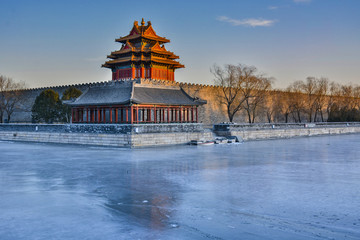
0,135,360,240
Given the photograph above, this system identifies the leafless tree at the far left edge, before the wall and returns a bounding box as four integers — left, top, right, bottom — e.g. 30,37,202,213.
0,76,25,123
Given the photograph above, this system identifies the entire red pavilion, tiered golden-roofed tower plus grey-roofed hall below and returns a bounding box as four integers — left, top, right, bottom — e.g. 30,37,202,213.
68,19,206,124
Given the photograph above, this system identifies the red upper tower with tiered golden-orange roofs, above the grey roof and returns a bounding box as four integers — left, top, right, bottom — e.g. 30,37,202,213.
102,19,185,81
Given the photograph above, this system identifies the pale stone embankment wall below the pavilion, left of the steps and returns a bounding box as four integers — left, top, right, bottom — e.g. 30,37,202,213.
0,123,213,148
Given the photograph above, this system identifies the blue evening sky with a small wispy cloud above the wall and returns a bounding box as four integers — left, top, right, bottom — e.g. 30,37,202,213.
0,0,360,88
